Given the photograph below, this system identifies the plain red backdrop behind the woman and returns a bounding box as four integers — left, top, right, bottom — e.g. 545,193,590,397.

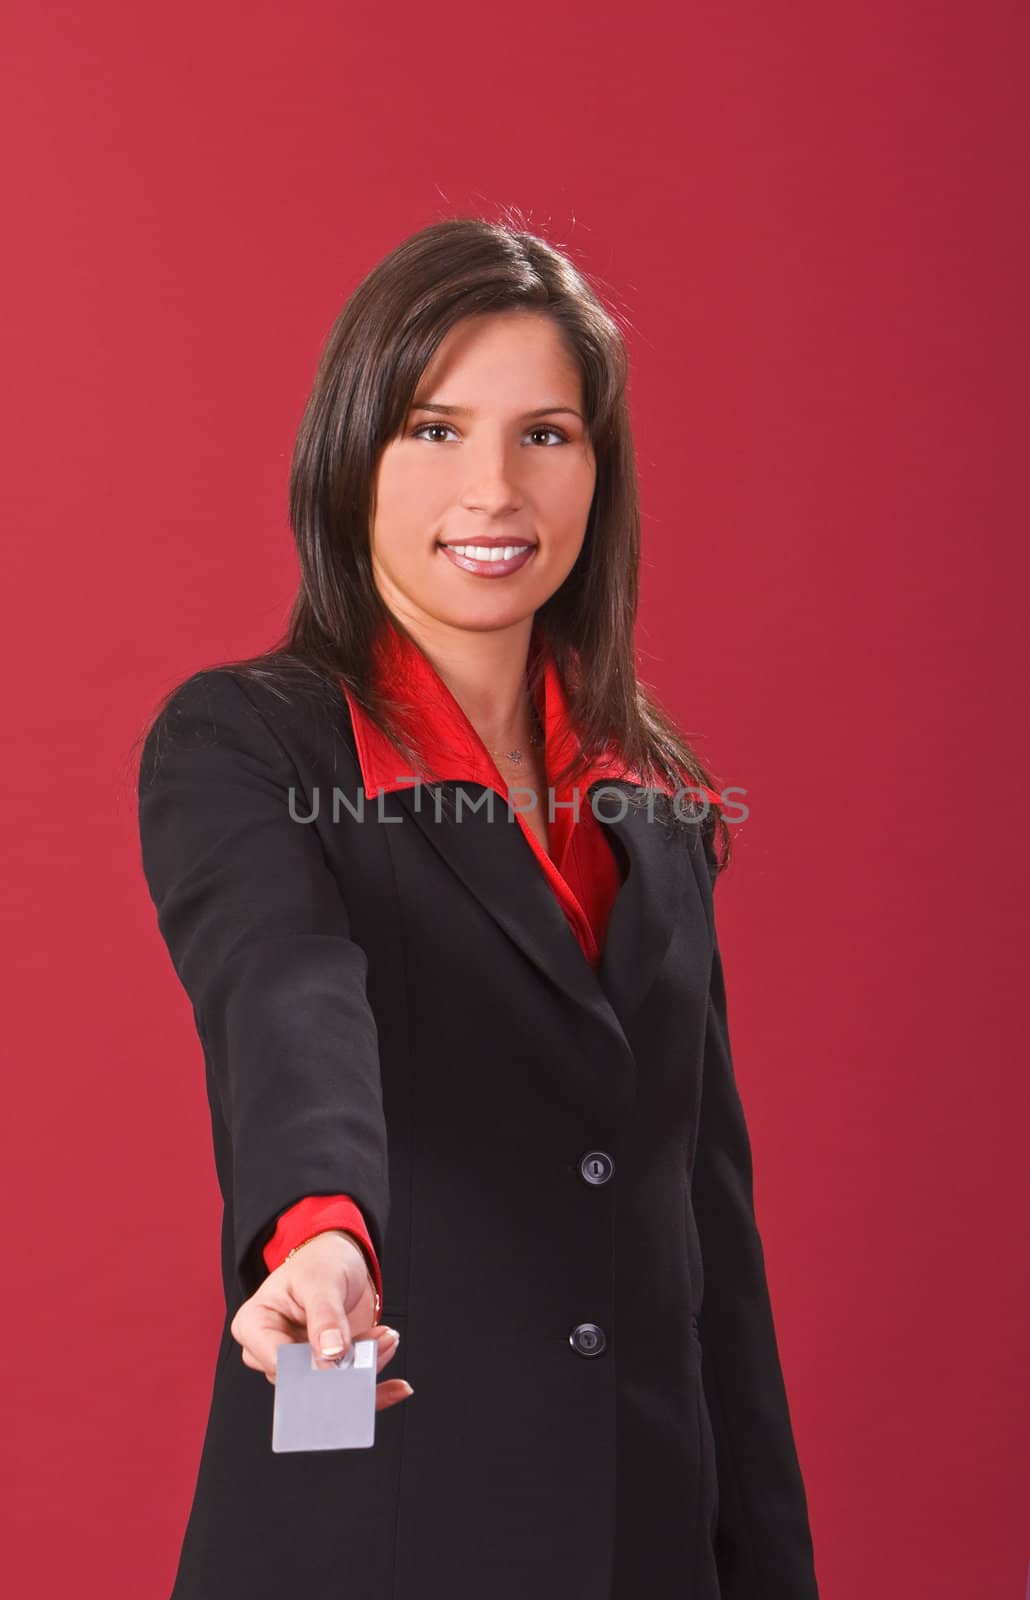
0,0,1030,1600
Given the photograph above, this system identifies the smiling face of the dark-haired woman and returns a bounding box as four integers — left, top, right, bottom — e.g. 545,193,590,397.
371,312,597,629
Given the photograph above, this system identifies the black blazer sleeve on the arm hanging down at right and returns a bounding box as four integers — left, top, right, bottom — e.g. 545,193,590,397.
693,837,819,1600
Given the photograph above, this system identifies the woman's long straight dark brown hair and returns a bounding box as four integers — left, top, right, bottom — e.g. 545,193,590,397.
132,216,731,870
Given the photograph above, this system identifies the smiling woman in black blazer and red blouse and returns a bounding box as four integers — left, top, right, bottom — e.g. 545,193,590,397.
139,219,817,1600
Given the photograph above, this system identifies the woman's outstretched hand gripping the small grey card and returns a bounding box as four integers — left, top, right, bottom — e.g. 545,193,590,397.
229,1229,414,1411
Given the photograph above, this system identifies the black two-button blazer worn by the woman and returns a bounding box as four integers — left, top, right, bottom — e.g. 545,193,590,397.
139,667,817,1600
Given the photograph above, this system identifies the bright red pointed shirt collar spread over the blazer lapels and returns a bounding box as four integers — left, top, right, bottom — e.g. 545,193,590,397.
341,624,721,803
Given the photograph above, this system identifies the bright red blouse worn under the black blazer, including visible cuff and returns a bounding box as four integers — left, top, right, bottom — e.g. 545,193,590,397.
262,627,721,1296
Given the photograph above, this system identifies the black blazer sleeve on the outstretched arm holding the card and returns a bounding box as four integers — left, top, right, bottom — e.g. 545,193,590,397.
139,667,389,1298
